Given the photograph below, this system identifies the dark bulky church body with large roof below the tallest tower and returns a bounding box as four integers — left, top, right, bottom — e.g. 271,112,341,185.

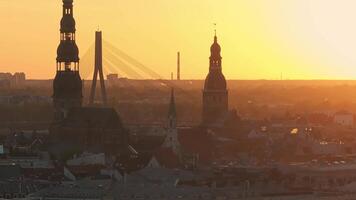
56,107,127,152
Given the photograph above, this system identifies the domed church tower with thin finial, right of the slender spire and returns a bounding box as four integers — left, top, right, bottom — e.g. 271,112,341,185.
202,32,228,126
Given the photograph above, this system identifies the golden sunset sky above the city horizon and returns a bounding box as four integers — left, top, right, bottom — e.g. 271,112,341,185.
0,0,356,79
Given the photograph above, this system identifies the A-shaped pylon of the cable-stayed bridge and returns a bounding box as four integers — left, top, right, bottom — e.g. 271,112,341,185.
89,31,107,105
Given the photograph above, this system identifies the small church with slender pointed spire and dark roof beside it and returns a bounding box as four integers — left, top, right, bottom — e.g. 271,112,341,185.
148,89,214,169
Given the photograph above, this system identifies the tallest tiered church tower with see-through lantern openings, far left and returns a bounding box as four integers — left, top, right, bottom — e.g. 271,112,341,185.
53,0,83,120
